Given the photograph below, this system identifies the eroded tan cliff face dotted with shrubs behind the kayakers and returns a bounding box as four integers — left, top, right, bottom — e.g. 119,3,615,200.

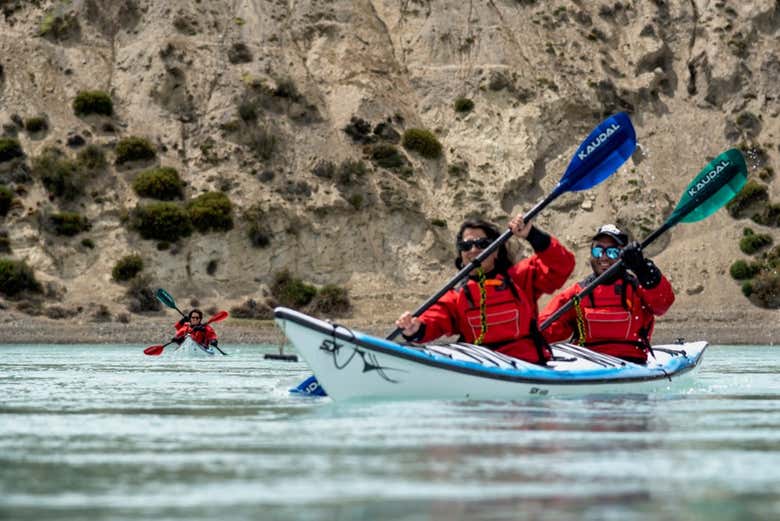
0,0,780,330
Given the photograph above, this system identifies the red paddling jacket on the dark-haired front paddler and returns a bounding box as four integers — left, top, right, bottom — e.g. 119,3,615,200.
407,234,574,362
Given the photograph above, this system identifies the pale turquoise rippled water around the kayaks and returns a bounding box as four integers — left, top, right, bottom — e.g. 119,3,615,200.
0,345,780,521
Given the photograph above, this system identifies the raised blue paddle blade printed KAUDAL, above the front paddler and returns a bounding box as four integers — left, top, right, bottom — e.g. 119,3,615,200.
555,112,636,192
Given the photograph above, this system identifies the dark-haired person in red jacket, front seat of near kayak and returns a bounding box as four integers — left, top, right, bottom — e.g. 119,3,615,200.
396,215,574,363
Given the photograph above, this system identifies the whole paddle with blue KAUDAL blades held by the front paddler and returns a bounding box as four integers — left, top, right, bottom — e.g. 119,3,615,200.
295,112,636,394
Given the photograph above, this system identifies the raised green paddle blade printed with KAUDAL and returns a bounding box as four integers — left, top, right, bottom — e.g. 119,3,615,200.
669,148,747,223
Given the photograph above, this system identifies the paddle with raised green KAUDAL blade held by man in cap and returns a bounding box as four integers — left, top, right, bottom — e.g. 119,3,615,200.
539,148,747,329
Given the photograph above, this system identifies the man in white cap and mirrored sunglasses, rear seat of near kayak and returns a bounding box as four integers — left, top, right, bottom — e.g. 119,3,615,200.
539,224,674,364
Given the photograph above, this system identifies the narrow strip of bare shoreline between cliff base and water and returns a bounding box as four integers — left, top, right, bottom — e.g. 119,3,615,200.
0,310,780,345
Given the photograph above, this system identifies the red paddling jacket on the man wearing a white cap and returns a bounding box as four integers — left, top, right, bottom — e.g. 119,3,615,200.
539,272,674,363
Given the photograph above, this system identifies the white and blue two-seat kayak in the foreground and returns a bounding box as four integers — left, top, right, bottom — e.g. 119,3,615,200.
274,307,707,400
